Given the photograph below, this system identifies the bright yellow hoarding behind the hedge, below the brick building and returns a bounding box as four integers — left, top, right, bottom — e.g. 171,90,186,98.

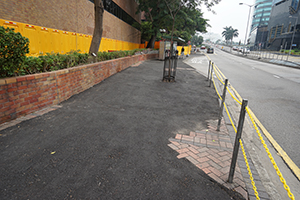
0,19,140,56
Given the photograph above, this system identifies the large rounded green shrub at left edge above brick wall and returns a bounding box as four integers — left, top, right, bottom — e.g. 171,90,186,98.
0,26,29,77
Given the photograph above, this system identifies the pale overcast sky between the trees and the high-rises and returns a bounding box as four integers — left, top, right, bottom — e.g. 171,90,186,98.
201,0,255,43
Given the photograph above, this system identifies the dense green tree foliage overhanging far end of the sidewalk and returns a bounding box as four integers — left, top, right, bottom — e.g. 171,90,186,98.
138,0,221,47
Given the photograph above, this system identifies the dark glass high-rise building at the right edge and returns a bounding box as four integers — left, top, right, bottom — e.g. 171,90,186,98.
267,0,300,50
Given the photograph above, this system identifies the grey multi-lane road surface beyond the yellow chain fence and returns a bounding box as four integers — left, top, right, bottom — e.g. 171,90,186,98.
190,48,300,167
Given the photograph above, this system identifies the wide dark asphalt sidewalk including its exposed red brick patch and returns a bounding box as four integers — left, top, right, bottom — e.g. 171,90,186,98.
0,57,247,199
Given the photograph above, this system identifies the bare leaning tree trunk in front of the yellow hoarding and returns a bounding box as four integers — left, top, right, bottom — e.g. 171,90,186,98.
89,0,104,55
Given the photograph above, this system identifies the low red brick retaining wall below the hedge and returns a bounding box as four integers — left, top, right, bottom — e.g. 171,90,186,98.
0,54,158,124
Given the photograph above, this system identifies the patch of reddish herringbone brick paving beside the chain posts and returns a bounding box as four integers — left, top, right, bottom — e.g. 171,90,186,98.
168,121,249,199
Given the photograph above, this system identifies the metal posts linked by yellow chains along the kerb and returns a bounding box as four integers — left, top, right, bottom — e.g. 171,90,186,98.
207,61,295,200
